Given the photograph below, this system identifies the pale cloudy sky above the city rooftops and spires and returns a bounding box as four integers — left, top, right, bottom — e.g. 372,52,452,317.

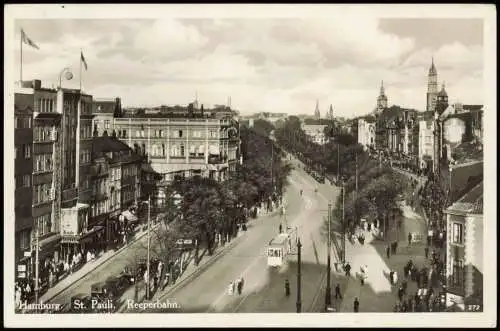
13,15,484,117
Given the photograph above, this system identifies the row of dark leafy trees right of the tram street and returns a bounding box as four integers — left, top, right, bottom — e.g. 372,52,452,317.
275,116,409,240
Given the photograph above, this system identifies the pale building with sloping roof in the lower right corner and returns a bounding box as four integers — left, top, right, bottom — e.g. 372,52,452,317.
445,182,484,309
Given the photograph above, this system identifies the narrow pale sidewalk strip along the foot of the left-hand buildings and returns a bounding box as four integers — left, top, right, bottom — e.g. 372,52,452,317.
39,224,159,302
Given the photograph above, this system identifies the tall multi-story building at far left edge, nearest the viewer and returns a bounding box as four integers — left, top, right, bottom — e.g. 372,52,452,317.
14,80,61,273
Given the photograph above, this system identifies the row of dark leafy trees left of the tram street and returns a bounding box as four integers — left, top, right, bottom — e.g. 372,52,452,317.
146,127,291,263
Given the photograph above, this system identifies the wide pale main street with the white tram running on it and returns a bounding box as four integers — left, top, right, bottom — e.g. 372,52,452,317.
148,161,344,312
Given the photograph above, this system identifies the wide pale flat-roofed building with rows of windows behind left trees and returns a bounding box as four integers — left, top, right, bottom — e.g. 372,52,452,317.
113,114,240,188
